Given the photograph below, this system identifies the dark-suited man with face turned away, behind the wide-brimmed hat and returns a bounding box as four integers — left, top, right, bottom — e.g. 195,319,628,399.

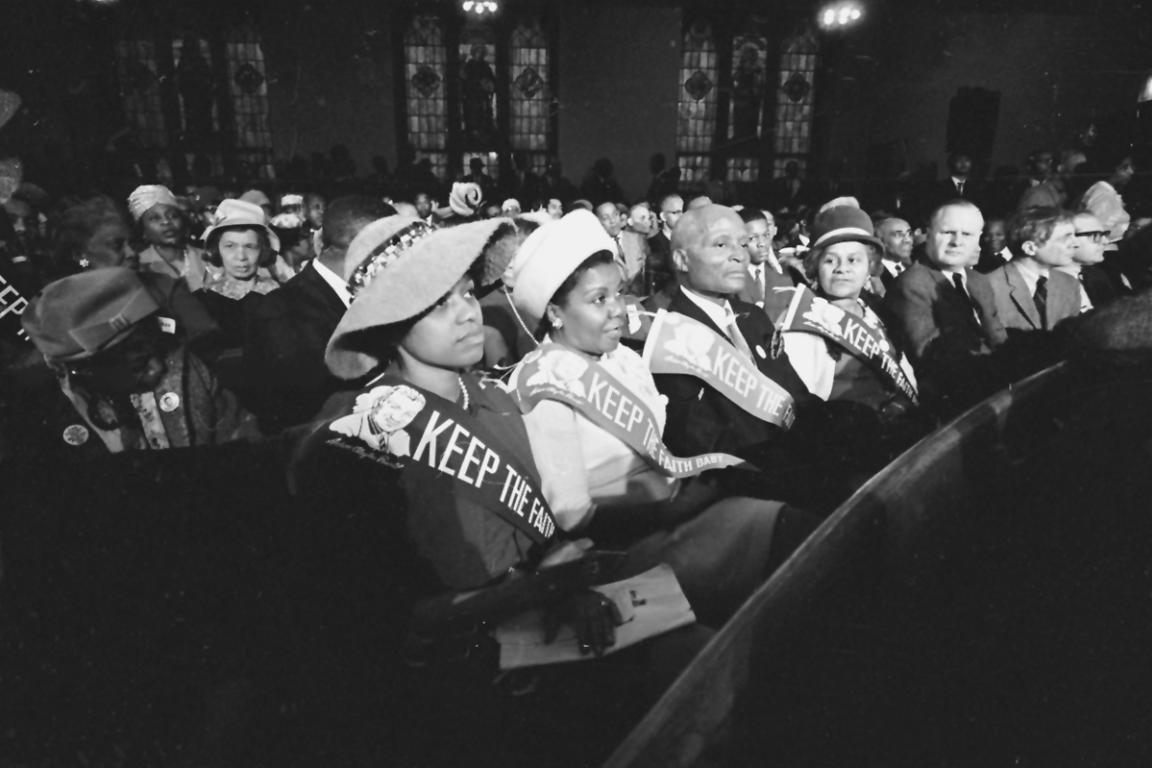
244,195,394,433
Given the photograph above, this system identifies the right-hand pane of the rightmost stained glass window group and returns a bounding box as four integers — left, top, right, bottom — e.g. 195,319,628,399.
775,32,817,163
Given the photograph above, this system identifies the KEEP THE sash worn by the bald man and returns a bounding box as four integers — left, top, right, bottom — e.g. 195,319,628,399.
644,310,796,429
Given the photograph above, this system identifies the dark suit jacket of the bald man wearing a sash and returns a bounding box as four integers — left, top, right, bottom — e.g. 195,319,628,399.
654,287,811,467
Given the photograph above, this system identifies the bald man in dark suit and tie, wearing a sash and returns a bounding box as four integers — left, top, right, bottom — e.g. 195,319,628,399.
655,205,809,481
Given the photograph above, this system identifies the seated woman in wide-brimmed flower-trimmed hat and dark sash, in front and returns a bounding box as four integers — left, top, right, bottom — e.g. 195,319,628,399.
295,219,707,765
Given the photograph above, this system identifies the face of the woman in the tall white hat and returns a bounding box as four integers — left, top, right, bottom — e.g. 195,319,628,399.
548,263,624,356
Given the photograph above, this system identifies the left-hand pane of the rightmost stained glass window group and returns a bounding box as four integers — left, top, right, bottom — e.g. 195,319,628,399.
676,22,719,183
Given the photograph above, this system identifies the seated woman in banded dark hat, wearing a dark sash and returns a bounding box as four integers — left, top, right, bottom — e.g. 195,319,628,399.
778,205,923,465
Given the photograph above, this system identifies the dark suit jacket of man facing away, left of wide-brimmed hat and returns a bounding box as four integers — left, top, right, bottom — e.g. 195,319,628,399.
244,266,356,432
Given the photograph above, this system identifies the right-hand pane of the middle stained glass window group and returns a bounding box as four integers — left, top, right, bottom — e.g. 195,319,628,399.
508,18,552,174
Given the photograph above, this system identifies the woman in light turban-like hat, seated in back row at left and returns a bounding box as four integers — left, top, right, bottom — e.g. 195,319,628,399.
128,184,206,290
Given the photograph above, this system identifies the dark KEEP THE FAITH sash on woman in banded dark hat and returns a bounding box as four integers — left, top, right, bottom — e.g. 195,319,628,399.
780,286,918,403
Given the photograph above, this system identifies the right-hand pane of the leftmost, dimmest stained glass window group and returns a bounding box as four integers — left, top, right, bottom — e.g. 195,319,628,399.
225,26,272,178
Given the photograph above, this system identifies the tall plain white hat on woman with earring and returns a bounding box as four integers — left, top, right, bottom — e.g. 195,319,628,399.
508,210,616,325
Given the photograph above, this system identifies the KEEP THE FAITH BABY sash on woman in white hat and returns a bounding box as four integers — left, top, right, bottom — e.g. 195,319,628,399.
516,343,744,478
